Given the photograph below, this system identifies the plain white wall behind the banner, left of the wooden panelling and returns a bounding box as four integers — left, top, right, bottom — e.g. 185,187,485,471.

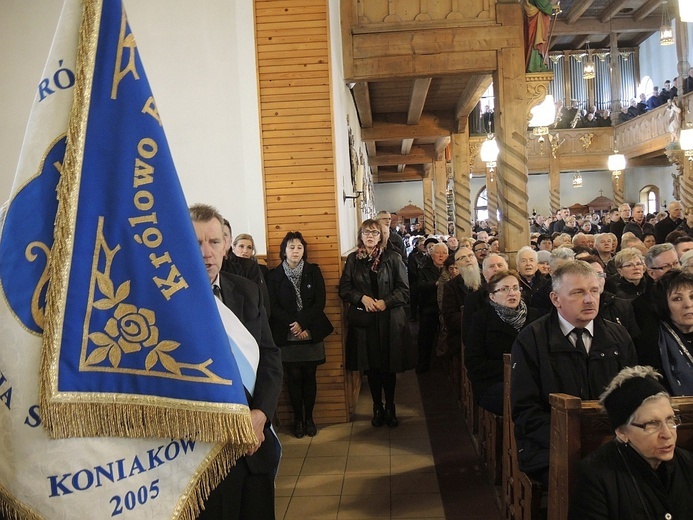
0,0,266,254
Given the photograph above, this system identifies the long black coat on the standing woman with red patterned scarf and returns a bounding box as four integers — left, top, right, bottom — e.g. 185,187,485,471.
339,250,418,372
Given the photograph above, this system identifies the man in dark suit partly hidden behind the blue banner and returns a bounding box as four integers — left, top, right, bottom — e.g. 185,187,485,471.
190,204,282,520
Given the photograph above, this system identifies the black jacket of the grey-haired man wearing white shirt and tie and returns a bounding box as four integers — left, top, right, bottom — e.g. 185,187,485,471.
510,310,637,472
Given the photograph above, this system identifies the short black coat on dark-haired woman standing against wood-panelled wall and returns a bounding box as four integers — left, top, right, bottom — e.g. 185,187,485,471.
267,261,334,346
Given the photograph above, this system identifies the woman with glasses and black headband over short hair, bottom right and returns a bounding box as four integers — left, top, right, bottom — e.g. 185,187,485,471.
568,366,693,520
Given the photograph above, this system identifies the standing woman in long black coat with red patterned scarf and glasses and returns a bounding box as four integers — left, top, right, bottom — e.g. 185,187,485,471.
339,219,417,428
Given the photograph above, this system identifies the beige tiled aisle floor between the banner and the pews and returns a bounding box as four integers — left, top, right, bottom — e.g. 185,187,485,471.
275,362,499,520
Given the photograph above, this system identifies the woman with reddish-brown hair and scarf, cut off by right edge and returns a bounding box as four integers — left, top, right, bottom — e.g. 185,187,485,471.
635,269,693,395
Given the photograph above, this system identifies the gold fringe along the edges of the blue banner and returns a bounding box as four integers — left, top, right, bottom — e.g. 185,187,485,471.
39,0,257,448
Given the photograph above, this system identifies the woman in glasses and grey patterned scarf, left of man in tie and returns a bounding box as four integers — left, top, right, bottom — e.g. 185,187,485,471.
464,270,541,415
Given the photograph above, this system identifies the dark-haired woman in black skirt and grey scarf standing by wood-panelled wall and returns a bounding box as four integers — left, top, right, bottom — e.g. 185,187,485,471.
267,231,334,439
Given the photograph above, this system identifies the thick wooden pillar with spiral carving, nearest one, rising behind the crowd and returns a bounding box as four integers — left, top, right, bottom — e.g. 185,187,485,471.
489,43,528,253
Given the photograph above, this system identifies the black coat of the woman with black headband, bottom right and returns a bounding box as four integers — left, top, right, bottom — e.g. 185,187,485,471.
568,440,693,520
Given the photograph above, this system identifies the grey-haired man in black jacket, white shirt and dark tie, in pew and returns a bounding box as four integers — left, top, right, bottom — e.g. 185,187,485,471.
510,260,637,485
